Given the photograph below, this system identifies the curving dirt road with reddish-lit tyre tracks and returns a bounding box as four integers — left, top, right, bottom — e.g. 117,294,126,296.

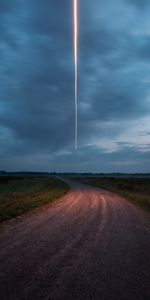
0,179,150,300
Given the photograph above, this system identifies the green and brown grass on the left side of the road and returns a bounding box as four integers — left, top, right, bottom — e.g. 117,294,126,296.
0,176,69,222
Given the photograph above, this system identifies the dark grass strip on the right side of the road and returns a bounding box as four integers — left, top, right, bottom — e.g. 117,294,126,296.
74,177,150,212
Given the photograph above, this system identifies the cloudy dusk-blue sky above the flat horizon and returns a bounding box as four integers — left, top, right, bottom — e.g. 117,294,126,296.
0,0,150,172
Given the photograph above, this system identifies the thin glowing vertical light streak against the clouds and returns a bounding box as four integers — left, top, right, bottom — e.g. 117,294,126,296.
73,0,78,149
